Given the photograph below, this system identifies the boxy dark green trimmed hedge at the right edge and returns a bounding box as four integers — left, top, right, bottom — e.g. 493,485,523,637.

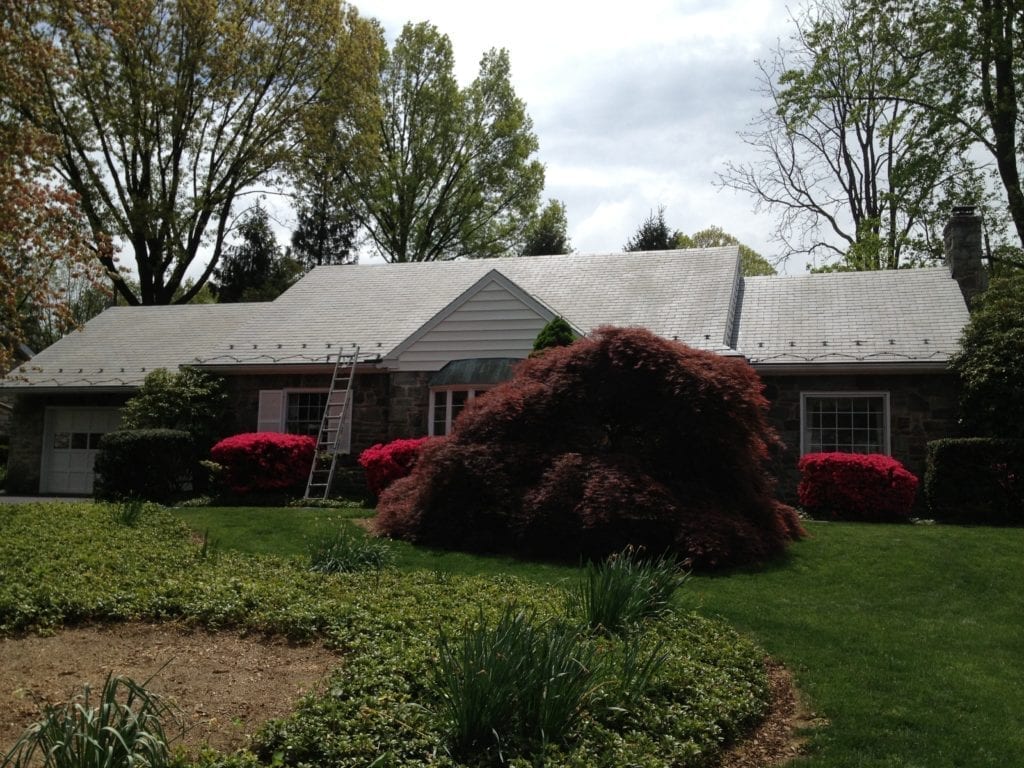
925,437,1024,525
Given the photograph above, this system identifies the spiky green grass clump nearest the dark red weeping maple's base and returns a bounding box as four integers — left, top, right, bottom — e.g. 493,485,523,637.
566,548,689,634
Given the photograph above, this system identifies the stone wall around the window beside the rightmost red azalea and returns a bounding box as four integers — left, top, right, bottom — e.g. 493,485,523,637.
762,373,959,503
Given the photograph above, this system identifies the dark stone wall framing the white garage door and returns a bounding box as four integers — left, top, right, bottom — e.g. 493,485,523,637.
6,393,129,494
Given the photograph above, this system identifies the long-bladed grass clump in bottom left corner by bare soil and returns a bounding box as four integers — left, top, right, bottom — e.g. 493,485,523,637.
2,674,173,768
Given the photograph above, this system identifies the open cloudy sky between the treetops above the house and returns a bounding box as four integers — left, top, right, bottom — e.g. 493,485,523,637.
356,0,803,273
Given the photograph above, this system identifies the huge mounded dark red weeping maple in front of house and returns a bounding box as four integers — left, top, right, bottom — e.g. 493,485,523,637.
377,328,803,566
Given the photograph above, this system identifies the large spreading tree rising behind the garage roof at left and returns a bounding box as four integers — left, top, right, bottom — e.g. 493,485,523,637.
0,0,378,304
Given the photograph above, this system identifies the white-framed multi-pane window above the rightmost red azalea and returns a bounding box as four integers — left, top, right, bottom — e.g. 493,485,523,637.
801,392,889,454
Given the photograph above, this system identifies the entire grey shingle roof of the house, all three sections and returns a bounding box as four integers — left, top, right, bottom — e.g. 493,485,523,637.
0,247,968,388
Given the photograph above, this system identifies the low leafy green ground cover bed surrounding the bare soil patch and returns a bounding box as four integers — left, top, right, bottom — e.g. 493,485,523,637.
0,505,770,766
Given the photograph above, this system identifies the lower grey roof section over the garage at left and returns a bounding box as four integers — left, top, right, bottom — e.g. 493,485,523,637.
0,304,259,390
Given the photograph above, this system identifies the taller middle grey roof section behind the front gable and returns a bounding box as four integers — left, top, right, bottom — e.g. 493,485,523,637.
197,246,739,369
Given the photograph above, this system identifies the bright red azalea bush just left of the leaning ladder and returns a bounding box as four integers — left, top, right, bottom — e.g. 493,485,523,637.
210,432,316,494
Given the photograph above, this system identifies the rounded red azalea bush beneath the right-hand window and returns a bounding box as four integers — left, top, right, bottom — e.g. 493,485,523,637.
797,454,918,522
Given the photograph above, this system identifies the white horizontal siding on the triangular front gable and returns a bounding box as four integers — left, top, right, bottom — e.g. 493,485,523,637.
397,282,547,371
